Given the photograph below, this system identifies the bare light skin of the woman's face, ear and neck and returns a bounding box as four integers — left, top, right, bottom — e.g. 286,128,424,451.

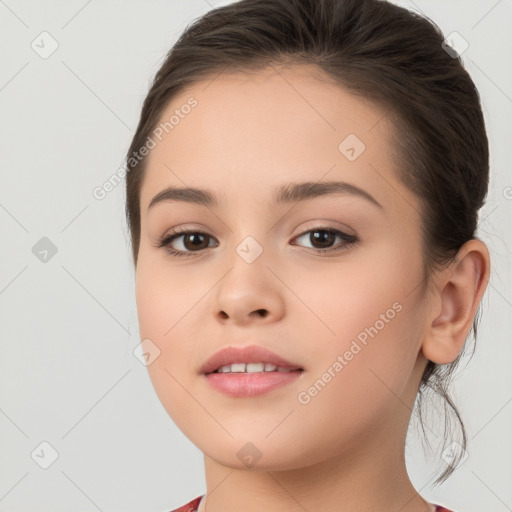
136,66,490,512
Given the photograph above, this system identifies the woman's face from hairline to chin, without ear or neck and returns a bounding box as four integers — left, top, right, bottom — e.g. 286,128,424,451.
136,67,432,469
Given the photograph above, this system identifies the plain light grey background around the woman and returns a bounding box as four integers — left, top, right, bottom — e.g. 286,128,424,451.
0,0,512,512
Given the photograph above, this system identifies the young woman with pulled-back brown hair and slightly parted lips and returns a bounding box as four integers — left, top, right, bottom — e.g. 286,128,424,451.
126,0,490,512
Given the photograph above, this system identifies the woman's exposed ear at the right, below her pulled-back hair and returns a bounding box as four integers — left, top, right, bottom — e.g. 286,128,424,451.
422,239,490,364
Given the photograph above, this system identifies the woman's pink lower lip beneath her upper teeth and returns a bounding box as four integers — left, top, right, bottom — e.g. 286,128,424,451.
206,370,303,398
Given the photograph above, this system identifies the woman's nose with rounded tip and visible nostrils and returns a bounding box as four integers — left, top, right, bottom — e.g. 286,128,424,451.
213,250,285,325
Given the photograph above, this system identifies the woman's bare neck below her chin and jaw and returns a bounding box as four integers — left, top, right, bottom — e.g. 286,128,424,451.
198,420,433,512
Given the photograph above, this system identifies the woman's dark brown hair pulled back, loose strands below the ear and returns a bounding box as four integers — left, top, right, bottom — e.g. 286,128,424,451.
126,0,489,484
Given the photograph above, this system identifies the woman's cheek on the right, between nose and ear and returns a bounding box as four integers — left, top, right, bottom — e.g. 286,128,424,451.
288,239,423,404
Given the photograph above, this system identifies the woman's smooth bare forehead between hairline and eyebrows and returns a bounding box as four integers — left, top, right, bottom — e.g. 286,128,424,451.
141,66,407,216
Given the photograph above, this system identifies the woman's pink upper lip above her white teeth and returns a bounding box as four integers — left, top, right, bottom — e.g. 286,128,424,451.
199,345,303,373
